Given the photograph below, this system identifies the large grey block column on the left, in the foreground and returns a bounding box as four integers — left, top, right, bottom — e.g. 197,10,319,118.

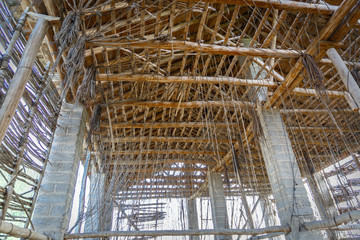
32,103,86,240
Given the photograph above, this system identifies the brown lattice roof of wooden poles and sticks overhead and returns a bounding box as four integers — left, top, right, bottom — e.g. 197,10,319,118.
16,0,360,202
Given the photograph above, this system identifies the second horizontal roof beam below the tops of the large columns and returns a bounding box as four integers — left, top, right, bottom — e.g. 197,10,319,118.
101,136,236,143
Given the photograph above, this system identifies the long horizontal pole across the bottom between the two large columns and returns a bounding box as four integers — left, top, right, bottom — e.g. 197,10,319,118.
64,226,290,239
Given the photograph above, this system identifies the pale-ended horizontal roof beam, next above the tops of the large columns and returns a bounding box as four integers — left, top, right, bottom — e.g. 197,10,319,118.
96,74,278,87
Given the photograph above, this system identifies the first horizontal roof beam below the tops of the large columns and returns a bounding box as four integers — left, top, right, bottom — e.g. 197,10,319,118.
100,122,240,129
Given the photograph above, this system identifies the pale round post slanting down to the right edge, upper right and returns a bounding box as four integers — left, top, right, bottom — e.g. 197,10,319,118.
326,48,360,110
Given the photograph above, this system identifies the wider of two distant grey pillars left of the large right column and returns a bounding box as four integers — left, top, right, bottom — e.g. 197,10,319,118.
208,173,229,240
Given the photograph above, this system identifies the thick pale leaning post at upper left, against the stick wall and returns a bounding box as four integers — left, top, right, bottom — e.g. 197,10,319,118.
0,18,49,142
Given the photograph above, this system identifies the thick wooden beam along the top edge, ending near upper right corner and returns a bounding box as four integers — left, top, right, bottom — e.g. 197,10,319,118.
180,0,338,15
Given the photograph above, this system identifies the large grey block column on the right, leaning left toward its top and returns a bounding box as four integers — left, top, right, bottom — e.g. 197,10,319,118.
259,108,322,240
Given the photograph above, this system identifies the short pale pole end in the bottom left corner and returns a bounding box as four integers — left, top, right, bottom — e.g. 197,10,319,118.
0,220,51,240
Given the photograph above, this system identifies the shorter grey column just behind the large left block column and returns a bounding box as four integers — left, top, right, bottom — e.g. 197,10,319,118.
85,172,113,232
